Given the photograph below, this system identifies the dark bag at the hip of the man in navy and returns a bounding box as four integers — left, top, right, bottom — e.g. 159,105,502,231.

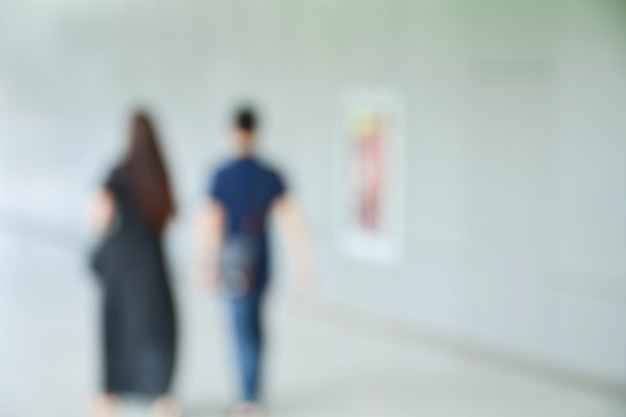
220,235,262,298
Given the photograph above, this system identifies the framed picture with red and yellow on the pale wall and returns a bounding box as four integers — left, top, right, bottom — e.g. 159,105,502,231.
334,89,408,265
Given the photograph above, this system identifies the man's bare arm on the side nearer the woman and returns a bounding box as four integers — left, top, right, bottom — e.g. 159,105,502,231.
193,197,225,286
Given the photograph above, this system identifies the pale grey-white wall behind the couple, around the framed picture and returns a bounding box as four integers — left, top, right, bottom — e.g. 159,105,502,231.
0,0,626,384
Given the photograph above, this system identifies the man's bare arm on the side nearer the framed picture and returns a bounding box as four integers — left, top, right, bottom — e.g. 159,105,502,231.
272,193,317,286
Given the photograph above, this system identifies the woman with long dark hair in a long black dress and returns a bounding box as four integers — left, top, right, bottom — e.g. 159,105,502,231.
86,112,178,417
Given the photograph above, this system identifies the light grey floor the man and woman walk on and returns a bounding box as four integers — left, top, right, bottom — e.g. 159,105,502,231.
0,232,626,417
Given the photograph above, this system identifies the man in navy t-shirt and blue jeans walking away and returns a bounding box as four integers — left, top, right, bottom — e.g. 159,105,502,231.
195,108,314,416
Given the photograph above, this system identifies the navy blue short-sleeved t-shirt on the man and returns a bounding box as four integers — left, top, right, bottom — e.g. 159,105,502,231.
209,157,286,240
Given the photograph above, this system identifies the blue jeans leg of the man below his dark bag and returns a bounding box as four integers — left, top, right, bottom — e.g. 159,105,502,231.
230,288,265,402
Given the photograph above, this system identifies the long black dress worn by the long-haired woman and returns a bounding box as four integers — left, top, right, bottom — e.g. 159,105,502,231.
99,169,176,397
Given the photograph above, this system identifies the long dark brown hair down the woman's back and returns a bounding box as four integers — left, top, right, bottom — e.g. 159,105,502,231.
123,111,176,234
